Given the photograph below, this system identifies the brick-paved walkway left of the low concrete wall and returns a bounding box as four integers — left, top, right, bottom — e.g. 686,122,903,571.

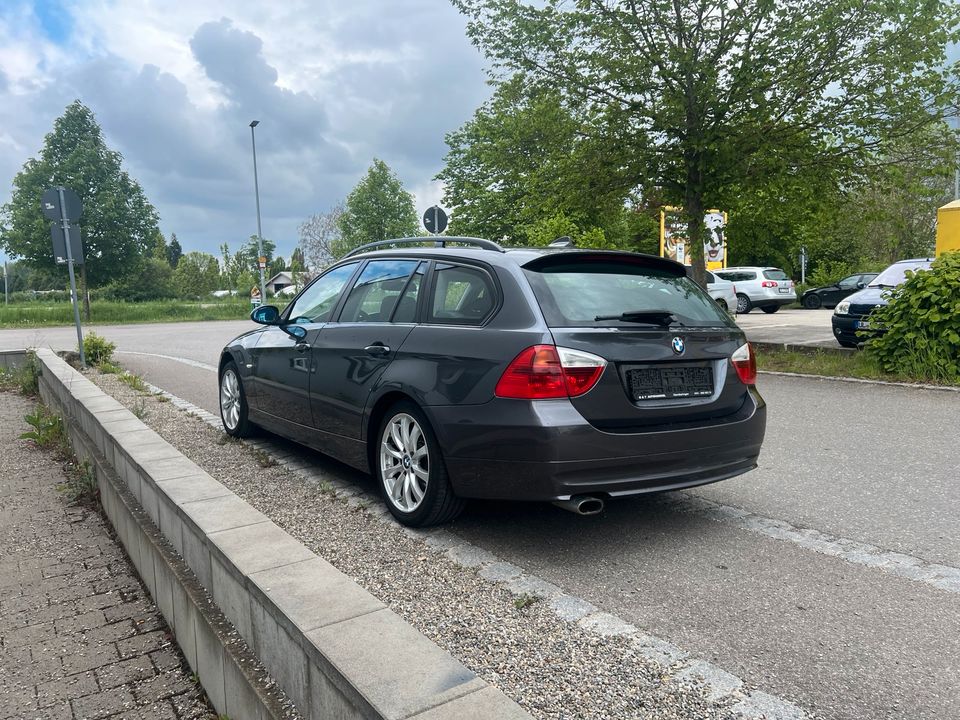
0,392,216,720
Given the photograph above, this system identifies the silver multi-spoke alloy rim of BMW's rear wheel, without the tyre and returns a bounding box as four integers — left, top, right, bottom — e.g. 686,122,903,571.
380,413,430,513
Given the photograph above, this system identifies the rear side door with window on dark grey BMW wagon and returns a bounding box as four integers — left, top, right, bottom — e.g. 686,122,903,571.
310,258,427,448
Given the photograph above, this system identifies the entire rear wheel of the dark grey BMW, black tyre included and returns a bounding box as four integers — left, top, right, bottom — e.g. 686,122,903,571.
371,400,466,527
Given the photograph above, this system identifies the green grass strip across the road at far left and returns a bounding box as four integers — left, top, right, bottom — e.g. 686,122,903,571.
0,298,252,327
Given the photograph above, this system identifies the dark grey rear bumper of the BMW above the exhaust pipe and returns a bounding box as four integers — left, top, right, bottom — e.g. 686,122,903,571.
425,390,766,501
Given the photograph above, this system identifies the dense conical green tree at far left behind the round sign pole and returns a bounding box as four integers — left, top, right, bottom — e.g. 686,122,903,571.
0,100,158,317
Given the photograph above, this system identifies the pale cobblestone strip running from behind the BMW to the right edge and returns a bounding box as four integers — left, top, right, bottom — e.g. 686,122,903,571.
664,493,960,593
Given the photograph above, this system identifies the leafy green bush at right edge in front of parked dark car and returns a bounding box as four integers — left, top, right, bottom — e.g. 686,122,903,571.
866,252,960,383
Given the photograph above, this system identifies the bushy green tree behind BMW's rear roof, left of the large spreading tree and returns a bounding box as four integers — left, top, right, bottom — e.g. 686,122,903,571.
437,74,656,247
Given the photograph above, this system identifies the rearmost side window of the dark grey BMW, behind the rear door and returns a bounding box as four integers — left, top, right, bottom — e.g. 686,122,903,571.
427,263,497,325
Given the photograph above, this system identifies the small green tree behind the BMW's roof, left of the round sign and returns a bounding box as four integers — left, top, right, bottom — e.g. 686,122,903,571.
333,158,418,256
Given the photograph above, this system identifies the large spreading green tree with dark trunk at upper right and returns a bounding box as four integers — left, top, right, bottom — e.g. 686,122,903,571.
452,0,960,282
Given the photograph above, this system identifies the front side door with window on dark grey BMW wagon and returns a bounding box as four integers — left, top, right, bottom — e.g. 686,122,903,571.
250,263,360,436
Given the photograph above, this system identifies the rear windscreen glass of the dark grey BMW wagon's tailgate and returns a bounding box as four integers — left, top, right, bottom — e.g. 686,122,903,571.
524,262,733,327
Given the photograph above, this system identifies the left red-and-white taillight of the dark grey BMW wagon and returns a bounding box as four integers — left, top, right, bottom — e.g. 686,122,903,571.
495,345,607,400
